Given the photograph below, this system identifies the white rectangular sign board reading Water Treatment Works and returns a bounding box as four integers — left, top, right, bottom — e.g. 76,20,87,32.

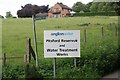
44,30,80,58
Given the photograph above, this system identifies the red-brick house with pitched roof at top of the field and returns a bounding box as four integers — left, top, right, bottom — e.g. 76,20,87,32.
48,3,72,18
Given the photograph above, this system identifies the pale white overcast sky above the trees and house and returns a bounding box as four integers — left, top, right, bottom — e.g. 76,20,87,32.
0,0,93,16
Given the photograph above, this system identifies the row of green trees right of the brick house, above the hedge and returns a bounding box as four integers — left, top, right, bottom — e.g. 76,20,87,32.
72,2,119,13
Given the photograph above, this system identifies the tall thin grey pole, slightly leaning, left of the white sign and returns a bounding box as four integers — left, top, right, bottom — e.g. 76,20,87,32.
32,15,38,67
